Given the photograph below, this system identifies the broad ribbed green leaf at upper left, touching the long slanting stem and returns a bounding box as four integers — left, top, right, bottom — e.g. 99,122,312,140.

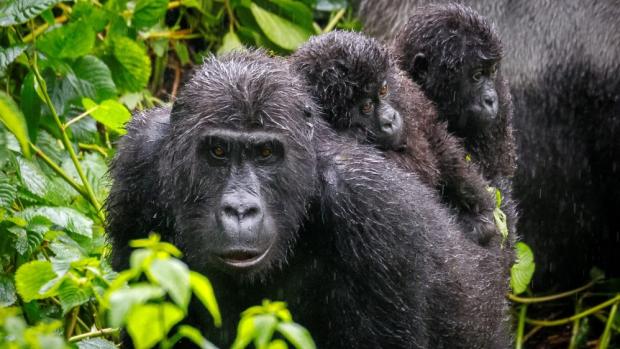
67,56,116,102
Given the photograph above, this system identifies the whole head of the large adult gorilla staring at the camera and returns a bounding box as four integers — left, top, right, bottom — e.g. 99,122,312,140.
160,54,316,279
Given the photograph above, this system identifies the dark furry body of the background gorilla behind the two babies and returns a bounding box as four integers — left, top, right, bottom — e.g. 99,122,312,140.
359,0,620,288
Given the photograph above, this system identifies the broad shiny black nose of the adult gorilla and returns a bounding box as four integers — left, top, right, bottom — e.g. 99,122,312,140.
220,193,263,230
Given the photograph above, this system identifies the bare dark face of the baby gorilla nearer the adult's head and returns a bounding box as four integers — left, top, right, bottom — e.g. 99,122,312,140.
349,81,404,149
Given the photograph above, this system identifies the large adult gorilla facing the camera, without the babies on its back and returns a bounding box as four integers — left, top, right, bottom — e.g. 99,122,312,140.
107,51,510,348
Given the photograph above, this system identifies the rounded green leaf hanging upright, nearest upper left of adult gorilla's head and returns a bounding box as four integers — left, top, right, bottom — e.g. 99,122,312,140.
109,37,151,92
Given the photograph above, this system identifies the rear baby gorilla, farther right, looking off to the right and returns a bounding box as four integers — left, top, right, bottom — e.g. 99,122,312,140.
394,4,516,185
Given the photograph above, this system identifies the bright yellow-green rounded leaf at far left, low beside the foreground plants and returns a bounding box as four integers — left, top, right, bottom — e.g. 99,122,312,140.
15,261,56,302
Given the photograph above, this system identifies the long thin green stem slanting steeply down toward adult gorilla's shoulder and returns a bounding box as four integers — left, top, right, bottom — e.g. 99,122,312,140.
31,57,105,222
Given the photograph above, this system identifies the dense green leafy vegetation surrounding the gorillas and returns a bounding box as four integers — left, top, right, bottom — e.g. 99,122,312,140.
0,0,620,348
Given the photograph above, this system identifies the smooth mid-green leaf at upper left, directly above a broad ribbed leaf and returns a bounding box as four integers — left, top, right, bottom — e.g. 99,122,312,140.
37,21,95,58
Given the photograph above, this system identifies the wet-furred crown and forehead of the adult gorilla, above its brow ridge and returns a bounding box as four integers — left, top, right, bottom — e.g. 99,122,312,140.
171,50,312,137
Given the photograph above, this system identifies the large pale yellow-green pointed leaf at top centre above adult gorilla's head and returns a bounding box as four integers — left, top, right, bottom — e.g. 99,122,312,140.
250,3,312,50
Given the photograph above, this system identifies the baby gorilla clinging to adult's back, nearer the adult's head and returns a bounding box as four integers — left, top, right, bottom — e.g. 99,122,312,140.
291,31,499,245
